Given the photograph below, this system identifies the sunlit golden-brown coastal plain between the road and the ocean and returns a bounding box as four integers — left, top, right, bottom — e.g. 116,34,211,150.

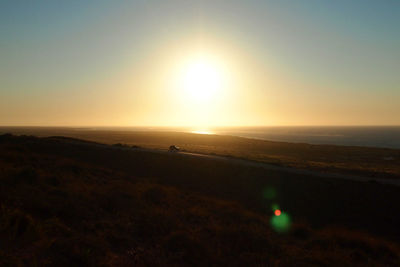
0,127,400,179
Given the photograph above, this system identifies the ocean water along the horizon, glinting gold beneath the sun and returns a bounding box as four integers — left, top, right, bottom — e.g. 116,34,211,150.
206,126,400,149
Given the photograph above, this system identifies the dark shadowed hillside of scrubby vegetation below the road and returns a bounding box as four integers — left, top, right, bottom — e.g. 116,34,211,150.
0,135,400,266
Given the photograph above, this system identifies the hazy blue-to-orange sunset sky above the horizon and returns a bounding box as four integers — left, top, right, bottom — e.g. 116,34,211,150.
0,0,400,126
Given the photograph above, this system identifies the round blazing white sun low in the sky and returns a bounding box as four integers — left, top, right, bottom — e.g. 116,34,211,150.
182,57,224,101
